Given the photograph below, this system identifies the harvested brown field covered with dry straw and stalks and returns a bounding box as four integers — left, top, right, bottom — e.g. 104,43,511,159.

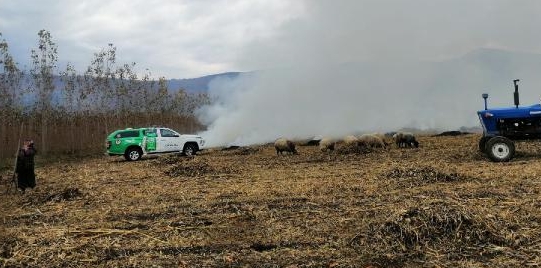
0,135,541,267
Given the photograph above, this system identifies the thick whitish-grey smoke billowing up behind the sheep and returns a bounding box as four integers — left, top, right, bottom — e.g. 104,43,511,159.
198,1,541,147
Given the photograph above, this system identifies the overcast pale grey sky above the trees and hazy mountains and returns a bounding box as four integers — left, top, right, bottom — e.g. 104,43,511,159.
0,0,541,78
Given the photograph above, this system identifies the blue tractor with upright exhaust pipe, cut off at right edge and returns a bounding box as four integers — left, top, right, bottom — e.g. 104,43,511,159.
477,79,541,162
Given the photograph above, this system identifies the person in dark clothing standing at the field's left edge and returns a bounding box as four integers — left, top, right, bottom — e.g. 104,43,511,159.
15,140,37,193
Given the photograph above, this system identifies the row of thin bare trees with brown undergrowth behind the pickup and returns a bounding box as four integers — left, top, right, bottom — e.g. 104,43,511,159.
0,30,209,161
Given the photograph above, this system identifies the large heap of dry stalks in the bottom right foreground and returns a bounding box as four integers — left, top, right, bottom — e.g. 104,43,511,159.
352,201,516,265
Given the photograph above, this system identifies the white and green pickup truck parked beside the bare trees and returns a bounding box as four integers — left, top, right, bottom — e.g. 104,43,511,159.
106,127,205,161
